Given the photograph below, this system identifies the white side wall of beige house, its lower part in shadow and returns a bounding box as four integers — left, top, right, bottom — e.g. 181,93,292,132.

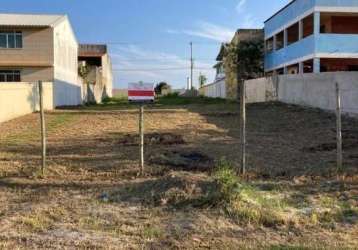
54,18,82,107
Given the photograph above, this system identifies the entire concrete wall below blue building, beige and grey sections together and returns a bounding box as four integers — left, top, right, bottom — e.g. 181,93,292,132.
245,72,358,115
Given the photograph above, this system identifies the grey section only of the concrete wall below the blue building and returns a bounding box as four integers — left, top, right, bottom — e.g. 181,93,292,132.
278,72,358,115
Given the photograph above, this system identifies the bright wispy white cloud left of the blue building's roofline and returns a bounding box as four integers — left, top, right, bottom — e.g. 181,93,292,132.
167,21,235,42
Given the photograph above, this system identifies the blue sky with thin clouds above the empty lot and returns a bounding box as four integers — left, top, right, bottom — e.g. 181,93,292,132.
0,0,289,88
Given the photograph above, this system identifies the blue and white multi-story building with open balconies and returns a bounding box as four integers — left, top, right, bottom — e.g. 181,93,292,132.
265,0,358,75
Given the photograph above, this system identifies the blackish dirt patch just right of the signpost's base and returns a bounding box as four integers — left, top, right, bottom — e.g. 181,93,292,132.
150,151,213,172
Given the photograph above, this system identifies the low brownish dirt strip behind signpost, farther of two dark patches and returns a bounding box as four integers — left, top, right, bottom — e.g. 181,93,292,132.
118,133,185,146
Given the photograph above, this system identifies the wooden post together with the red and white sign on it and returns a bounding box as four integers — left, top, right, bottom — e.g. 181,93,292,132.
128,83,154,174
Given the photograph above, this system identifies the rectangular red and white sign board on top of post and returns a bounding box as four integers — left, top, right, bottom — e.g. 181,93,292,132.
128,83,154,102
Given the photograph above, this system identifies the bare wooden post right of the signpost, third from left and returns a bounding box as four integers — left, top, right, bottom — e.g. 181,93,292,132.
240,80,246,175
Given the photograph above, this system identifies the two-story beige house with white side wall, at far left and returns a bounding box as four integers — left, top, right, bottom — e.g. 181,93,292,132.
0,14,82,107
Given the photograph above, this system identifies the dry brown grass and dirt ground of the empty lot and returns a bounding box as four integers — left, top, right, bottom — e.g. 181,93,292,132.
0,100,358,249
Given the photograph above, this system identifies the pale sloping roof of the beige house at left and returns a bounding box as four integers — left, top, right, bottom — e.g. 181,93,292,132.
0,14,66,27
